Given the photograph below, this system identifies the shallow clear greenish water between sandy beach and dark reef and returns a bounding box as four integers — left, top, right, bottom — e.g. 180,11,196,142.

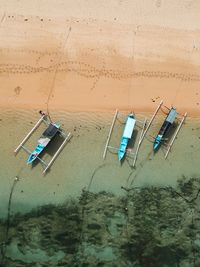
0,110,200,220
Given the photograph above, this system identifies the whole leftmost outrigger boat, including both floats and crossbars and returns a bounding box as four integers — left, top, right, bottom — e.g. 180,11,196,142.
14,113,71,174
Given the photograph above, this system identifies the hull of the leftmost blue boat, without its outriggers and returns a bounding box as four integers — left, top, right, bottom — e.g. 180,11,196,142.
27,123,60,164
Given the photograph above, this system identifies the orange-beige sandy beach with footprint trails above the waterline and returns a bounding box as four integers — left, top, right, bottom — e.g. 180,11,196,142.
0,0,200,116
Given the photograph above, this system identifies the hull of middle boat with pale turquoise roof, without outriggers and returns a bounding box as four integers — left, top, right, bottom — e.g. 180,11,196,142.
118,113,136,161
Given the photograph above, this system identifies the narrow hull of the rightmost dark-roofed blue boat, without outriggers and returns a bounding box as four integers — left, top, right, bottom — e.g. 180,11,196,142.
153,107,177,151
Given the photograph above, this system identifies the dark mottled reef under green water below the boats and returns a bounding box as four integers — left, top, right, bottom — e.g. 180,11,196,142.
0,177,200,267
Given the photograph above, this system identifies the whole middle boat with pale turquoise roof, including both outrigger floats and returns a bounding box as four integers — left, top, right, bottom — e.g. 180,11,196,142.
103,110,147,167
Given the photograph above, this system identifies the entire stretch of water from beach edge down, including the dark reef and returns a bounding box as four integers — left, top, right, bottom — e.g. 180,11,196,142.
0,110,200,266
